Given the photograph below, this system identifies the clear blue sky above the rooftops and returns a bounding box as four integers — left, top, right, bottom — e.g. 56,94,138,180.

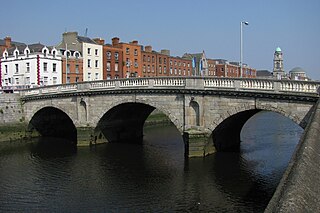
0,0,320,80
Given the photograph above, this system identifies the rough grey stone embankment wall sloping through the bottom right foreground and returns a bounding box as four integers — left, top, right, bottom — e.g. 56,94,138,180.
265,99,320,213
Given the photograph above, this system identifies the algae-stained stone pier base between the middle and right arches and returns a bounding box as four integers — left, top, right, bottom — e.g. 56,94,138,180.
183,129,216,157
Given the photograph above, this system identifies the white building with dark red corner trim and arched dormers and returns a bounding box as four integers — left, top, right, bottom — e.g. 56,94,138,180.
0,43,62,90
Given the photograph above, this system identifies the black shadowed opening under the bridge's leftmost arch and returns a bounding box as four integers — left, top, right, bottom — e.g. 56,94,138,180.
28,107,77,146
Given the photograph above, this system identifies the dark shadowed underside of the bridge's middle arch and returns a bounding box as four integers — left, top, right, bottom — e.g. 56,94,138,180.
94,103,155,143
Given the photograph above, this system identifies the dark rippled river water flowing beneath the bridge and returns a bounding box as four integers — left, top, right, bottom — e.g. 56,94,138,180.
0,112,303,212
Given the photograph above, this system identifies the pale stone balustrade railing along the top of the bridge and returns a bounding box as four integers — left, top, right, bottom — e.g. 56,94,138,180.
21,77,320,96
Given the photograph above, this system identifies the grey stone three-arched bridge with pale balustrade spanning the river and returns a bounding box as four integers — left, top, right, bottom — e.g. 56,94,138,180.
20,77,320,157
